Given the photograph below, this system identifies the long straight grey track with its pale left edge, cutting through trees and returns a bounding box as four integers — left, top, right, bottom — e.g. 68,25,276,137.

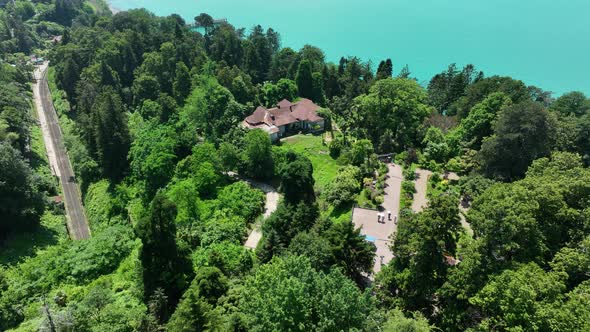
33,63,90,240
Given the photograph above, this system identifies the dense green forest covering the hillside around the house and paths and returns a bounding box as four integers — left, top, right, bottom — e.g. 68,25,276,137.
0,0,590,331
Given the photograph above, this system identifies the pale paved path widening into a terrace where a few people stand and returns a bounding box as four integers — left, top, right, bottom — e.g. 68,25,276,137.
352,164,403,273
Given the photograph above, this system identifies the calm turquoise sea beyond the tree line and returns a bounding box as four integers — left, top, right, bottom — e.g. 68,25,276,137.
110,0,590,95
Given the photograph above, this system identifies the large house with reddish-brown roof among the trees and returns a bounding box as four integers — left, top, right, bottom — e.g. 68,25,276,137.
242,98,324,142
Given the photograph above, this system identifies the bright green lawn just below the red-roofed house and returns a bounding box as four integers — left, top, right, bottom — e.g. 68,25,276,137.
281,135,341,190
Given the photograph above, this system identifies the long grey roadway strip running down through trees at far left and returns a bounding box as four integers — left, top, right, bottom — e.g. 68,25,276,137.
37,65,90,240
